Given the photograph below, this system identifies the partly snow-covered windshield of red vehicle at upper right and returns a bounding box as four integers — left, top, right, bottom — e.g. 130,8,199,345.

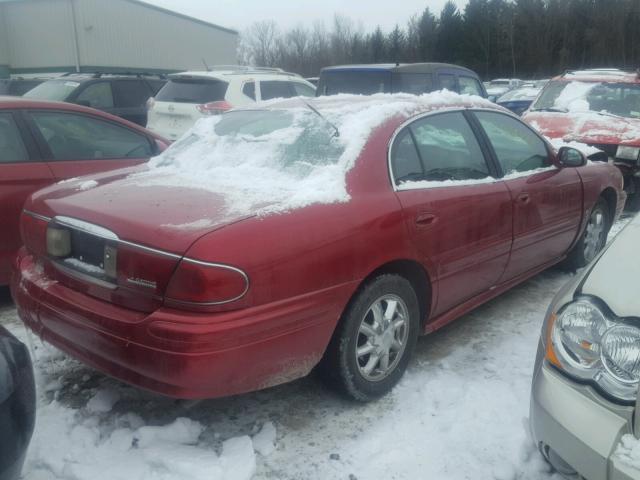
532,81,640,118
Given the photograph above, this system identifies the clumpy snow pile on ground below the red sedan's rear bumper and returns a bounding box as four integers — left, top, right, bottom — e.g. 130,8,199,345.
25,397,256,480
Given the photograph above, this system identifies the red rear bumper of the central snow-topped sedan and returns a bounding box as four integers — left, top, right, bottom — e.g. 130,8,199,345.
11,250,355,398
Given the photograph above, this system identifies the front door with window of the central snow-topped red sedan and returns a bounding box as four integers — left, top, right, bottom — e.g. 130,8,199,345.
474,111,582,280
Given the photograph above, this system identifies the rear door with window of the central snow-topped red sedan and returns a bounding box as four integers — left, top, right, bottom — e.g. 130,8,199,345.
390,112,512,316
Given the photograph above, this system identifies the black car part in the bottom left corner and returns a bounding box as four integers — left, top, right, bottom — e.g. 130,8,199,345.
0,326,36,480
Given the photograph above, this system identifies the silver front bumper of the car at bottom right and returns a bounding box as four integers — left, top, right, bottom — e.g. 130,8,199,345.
530,348,640,480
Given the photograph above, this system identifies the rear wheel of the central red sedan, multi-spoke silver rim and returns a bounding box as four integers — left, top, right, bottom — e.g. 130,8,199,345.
320,274,420,401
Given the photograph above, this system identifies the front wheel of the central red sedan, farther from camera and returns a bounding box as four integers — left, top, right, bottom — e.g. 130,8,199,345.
565,198,611,270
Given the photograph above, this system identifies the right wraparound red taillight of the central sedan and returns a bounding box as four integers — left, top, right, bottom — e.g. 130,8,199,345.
166,258,249,305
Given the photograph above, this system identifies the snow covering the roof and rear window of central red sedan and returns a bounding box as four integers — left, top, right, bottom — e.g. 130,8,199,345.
124,90,492,215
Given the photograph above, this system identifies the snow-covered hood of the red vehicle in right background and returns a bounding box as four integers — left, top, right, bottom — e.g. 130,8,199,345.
523,111,640,146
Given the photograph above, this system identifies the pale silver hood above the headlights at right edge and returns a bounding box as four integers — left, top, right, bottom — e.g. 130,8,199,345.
582,212,640,317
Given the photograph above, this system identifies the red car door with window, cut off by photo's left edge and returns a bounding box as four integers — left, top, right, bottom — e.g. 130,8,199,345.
0,110,54,285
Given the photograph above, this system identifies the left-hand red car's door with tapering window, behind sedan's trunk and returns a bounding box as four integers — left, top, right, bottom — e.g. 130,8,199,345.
28,110,156,180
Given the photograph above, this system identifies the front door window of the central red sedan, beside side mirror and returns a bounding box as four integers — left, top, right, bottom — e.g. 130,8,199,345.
475,112,551,175
